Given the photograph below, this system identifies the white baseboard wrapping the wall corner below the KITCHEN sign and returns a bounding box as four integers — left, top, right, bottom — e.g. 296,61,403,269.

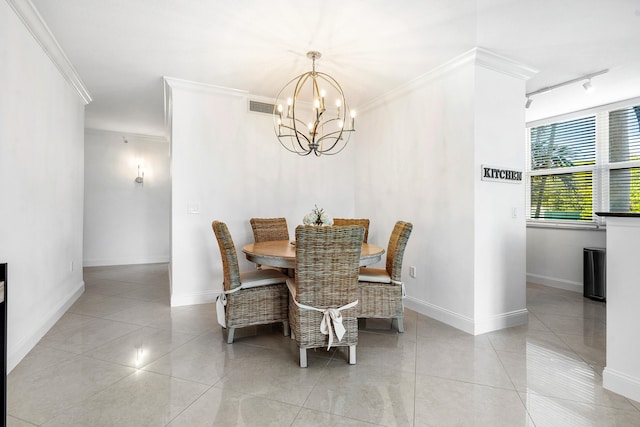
404,297,529,335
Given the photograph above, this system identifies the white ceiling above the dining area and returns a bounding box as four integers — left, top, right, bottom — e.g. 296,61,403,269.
31,0,640,135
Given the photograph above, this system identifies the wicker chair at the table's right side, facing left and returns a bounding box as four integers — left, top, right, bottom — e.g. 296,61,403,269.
358,221,413,332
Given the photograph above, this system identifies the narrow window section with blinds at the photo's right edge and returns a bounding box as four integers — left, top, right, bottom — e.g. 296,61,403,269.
609,106,640,212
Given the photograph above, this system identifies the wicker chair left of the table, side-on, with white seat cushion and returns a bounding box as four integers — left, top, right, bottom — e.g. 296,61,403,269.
211,221,289,344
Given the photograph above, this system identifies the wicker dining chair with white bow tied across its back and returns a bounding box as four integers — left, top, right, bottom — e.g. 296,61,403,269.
287,225,364,368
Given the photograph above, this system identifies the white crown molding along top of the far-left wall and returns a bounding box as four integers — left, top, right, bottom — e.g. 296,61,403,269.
7,0,92,105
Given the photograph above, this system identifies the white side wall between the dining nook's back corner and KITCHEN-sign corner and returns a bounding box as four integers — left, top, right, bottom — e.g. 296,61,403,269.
356,60,474,320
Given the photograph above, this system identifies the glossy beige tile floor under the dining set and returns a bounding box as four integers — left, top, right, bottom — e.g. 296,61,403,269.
7,264,640,427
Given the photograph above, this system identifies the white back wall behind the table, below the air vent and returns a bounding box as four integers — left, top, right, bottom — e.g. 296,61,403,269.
167,79,362,306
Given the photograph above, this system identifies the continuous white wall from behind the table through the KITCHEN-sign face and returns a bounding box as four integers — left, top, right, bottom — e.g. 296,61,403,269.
167,51,526,333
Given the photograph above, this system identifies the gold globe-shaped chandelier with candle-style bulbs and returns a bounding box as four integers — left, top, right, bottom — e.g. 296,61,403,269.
273,51,355,156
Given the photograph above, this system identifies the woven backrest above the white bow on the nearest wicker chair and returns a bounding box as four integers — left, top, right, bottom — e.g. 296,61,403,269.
295,225,364,308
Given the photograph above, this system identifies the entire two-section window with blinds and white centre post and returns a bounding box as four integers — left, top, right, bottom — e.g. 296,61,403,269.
527,105,640,223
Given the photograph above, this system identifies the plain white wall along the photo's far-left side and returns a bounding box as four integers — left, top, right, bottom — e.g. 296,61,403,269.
0,1,84,370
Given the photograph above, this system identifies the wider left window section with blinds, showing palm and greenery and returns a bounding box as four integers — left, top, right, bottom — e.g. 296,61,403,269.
529,116,596,221
